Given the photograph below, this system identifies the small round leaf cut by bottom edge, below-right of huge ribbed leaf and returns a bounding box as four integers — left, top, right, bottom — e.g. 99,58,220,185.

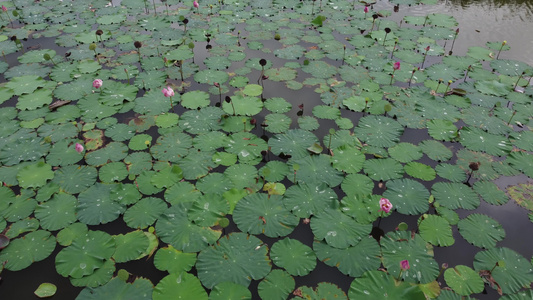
257,269,295,300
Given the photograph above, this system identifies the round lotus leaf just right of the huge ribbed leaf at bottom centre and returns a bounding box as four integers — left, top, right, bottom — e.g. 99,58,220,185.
270,238,316,276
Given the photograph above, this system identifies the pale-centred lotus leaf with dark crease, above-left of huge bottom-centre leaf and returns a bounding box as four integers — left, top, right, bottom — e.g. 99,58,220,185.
188,193,230,227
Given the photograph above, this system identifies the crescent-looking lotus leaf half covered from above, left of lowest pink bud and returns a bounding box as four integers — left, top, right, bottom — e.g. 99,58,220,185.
313,237,381,277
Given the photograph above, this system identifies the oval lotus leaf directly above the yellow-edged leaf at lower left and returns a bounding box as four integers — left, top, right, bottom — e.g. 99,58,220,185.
124,197,168,229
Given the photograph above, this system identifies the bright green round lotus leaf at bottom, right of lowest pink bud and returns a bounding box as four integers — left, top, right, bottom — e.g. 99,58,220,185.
444,265,484,296
